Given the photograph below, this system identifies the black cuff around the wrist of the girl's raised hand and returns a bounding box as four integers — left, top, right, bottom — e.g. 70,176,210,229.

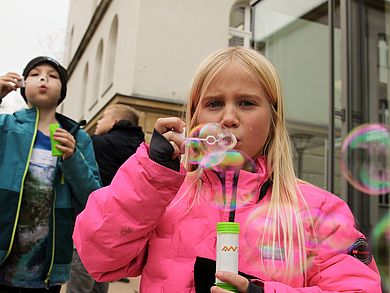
149,130,180,171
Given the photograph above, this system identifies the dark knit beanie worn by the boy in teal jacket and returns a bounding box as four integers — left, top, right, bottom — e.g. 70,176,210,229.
20,56,68,105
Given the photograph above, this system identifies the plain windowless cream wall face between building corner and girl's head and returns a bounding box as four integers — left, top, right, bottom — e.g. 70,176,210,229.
134,0,234,99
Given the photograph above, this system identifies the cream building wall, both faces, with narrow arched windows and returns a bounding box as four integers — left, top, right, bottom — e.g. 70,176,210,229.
63,0,235,120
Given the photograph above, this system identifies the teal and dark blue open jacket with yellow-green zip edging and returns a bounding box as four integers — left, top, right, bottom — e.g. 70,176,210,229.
0,108,101,286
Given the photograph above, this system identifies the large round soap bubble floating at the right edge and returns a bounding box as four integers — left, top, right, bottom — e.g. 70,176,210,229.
340,124,390,195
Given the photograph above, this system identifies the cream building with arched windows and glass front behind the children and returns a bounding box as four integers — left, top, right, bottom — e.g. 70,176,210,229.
61,0,390,288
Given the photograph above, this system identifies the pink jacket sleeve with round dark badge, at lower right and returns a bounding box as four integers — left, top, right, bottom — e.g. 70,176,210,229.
264,190,382,293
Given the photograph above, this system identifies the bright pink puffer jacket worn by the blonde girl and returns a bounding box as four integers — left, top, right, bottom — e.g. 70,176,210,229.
73,144,381,293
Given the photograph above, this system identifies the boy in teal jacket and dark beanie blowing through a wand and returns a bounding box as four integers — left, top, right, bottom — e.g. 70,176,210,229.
0,56,101,292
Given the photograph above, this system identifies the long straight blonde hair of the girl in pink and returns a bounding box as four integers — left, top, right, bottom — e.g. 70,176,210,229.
184,47,314,283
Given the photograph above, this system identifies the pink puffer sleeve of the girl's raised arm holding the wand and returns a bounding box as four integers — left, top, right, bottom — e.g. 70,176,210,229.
73,144,185,281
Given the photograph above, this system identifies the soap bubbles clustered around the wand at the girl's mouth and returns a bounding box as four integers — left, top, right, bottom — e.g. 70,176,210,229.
184,122,254,171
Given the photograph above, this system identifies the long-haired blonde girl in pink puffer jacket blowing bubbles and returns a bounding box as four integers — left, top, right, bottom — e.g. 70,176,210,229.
73,48,381,293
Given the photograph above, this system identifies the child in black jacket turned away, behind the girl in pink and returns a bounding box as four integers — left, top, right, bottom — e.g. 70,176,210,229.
66,104,145,293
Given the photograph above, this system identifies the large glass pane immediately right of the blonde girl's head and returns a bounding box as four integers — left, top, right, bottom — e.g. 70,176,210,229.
252,0,341,189
